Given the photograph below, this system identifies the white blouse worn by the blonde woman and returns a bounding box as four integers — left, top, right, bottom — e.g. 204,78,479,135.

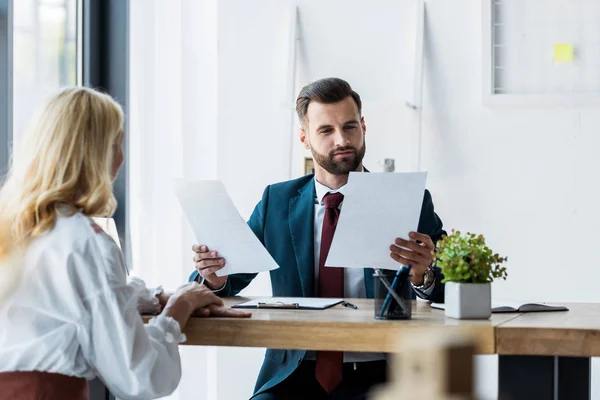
0,213,182,399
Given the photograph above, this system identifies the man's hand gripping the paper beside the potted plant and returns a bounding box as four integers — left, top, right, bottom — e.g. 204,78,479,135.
390,232,435,286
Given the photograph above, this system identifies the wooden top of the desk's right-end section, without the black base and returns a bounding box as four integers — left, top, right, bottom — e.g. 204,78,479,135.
496,303,600,357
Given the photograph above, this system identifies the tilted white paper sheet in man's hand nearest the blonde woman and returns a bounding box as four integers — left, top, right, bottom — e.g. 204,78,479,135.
175,180,279,276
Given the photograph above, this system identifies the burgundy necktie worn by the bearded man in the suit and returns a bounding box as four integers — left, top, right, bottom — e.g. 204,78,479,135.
316,193,344,393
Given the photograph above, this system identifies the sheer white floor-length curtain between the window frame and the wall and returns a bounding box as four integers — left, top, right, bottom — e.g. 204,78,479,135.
129,0,217,399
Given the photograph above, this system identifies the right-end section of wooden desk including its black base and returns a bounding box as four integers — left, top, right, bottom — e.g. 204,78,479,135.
496,303,600,400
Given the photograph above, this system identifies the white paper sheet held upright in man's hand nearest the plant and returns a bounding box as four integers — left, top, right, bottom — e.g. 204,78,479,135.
325,172,427,270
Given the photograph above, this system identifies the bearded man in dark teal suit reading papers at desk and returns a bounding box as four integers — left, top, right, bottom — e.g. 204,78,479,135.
190,78,445,400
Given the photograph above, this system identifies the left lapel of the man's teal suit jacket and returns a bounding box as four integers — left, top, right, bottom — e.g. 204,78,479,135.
289,179,315,297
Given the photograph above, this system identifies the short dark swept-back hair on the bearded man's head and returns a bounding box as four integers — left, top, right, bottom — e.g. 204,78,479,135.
296,78,362,127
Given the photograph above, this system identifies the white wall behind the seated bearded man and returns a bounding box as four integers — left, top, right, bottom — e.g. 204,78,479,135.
131,0,600,400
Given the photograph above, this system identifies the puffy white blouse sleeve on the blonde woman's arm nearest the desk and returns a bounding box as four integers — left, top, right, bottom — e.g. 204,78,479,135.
76,236,185,399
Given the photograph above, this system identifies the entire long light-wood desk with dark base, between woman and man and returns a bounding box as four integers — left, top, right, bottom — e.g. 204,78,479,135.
173,297,600,400
